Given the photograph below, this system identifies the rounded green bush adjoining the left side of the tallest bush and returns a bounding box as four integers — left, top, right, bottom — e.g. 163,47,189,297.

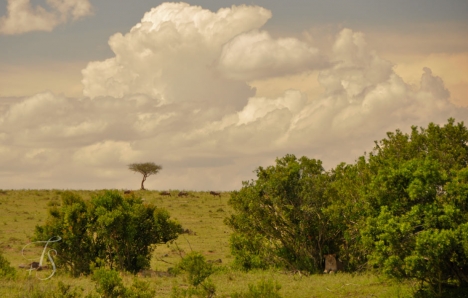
225,154,341,272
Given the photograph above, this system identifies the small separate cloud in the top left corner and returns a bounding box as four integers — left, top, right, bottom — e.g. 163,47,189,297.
0,0,92,35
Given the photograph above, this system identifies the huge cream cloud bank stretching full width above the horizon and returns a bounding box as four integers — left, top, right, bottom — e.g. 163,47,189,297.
0,3,468,190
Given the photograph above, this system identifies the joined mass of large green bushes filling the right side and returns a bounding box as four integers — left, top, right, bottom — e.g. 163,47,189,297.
226,119,468,295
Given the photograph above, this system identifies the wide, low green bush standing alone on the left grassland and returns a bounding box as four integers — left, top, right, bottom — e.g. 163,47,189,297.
35,191,181,275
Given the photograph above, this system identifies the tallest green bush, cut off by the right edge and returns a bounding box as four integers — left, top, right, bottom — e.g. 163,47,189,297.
361,119,468,297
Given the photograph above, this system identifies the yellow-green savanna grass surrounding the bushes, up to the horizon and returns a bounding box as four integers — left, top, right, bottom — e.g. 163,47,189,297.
0,190,413,297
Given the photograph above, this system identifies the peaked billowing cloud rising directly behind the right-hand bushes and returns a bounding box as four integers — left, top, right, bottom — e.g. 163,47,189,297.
280,29,462,158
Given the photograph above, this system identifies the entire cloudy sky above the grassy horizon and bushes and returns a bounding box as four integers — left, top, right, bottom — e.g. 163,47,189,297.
0,0,468,191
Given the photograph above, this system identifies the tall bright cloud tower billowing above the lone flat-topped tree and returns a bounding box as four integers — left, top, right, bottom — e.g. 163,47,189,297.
82,3,271,107
